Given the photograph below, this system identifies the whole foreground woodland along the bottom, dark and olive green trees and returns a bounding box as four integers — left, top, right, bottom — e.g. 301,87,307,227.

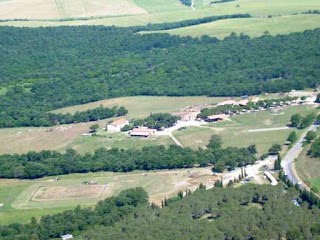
0,184,320,240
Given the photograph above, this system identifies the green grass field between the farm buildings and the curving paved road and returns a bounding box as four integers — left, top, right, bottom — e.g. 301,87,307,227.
173,106,318,155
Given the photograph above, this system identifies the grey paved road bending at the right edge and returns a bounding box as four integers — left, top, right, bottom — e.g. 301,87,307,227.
281,124,319,184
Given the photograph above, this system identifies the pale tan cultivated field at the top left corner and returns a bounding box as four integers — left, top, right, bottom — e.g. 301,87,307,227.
0,0,147,19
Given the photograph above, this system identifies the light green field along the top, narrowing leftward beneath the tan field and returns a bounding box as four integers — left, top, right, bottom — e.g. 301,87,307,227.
0,0,320,27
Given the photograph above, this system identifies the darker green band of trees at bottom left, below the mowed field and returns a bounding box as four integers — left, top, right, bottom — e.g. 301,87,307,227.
0,188,148,240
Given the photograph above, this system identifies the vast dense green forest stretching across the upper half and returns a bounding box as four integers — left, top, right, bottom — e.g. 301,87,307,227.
0,23,320,127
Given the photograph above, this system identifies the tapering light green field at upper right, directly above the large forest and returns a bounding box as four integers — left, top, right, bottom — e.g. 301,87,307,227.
147,14,320,39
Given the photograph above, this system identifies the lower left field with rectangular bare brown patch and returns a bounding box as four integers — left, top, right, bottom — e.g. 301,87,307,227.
0,168,217,224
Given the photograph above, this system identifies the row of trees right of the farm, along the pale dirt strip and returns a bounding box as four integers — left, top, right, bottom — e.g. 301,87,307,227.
198,97,295,119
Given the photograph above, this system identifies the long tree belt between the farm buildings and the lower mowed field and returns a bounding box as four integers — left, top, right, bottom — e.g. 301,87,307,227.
0,142,256,179
